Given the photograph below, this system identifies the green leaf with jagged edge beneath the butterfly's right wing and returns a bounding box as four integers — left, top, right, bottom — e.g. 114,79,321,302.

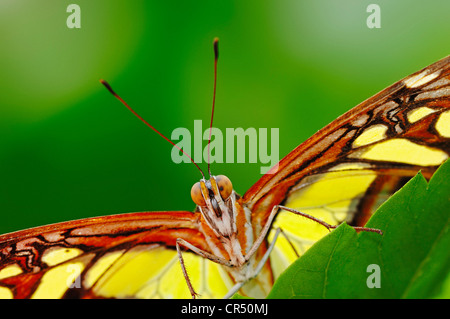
268,161,450,298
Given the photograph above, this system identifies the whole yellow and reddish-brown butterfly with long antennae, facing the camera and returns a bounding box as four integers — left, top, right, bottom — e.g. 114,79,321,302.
0,40,450,298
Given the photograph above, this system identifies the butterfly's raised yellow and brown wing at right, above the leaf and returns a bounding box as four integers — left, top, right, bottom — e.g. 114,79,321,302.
243,57,450,273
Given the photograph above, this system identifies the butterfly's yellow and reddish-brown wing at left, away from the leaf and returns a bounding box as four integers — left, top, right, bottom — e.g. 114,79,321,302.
0,212,233,298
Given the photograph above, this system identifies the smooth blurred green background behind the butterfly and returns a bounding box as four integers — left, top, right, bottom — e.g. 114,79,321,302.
0,0,450,233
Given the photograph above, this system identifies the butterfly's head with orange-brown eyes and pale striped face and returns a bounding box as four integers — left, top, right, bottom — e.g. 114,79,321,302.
191,175,236,237
